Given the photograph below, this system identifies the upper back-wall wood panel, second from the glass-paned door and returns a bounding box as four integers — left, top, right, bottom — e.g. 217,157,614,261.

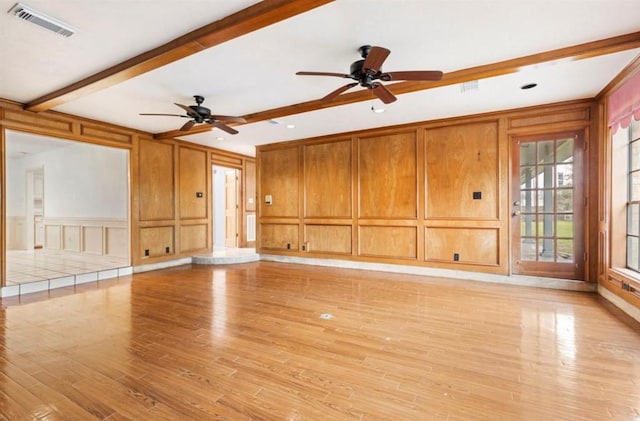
358,131,418,219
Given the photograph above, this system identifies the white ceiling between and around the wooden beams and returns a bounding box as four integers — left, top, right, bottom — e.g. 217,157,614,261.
0,0,640,155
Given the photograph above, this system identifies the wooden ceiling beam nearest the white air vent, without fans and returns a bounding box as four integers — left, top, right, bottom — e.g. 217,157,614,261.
24,0,334,112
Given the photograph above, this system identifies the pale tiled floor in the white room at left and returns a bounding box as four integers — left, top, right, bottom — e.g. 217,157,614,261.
7,249,129,286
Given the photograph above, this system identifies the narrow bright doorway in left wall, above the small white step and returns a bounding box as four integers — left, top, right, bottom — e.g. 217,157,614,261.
212,165,240,251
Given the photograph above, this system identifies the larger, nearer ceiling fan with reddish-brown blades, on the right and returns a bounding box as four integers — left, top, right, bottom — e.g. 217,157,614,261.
296,45,442,104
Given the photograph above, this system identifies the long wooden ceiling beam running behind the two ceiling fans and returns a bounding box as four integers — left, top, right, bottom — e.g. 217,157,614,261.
235,32,640,124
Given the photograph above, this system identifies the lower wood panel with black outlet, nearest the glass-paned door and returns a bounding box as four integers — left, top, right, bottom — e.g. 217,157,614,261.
425,227,500,266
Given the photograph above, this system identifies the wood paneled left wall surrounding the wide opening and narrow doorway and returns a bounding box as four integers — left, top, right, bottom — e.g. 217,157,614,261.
0,100,255,282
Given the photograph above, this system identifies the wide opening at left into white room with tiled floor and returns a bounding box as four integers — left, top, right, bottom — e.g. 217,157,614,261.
3,130,130,291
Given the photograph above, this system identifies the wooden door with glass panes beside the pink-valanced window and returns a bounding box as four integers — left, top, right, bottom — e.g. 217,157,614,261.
511,131,585,280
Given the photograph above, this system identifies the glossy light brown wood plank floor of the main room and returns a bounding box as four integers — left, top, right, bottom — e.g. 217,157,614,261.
0,262,640,421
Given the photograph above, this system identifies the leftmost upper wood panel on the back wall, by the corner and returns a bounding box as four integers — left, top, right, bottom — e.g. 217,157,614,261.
259,146,300,217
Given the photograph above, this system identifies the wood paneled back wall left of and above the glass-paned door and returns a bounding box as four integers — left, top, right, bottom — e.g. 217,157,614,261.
256,101,597,280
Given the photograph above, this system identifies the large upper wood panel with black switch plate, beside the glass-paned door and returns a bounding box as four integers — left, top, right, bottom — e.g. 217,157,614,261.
425,121,500,219
